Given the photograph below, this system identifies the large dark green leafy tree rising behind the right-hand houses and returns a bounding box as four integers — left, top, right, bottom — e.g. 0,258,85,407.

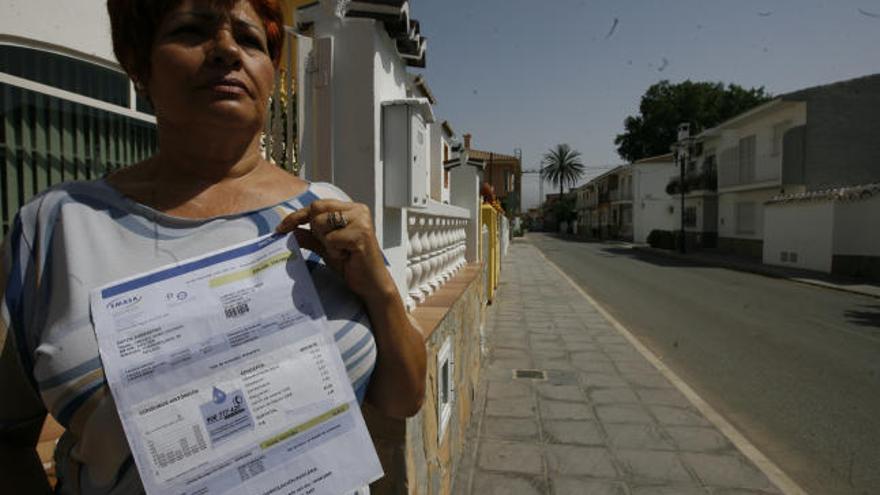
614,81,771,162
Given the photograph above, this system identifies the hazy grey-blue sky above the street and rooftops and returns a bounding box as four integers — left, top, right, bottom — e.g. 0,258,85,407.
410,0,880,207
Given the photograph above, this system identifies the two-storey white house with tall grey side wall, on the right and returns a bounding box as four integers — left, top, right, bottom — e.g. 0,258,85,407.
698,74,880,258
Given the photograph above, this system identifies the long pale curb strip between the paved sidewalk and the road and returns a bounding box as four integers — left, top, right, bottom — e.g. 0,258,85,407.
533,244,807,495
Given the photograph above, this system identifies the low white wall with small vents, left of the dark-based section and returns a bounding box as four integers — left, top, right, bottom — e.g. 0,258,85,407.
763,201,836,273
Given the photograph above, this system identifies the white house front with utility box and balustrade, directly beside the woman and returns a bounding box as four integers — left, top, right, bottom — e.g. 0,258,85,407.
296,1,479,306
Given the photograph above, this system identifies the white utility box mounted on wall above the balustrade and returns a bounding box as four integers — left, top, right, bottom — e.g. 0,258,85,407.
382,98,434,208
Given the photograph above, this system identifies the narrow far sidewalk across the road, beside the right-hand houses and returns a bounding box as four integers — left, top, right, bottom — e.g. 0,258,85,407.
626,243,880,298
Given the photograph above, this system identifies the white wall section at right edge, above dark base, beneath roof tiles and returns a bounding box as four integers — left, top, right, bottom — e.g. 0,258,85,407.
834,196,880,256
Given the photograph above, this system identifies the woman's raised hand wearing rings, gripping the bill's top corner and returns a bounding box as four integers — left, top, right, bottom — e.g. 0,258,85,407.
276,199,397,302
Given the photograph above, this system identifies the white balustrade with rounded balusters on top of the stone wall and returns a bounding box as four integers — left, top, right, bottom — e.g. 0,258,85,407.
406,205,470,310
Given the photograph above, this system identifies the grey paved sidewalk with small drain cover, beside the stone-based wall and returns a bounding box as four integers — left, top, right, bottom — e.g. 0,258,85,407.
452,240,796,495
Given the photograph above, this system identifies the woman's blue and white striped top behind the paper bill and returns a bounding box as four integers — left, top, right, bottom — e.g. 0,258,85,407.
0,180,376,495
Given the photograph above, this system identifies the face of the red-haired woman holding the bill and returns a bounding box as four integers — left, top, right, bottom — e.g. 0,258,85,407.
146,0,275,131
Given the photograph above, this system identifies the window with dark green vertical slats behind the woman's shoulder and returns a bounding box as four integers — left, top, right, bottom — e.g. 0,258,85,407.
0,45,157,235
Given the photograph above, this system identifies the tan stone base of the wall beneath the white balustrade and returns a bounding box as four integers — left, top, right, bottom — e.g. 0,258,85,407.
364,264,485,495
